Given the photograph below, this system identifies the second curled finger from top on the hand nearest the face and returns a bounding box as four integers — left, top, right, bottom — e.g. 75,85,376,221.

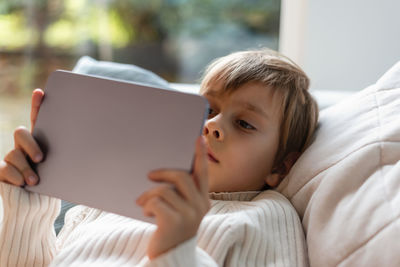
136,185,188,213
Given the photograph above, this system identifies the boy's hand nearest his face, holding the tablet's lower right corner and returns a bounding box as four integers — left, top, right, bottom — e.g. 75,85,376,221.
137,137,210,259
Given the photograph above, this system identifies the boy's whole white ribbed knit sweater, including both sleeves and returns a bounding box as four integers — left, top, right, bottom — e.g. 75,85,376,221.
0,183,308,267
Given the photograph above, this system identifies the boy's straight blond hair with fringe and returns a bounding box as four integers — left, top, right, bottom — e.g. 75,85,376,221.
200,49,318,172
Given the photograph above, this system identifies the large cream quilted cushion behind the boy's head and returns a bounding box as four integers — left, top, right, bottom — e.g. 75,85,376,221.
277,62,400,266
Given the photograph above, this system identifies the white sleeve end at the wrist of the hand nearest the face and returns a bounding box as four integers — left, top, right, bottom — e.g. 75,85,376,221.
143,237,218,267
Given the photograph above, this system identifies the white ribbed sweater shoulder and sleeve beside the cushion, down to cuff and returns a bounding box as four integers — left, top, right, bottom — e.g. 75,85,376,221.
144,191,308,267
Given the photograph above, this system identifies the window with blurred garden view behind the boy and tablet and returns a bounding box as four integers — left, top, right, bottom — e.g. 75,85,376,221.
0,0,280,156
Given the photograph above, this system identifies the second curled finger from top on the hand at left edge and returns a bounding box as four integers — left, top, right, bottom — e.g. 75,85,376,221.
4,149,39,185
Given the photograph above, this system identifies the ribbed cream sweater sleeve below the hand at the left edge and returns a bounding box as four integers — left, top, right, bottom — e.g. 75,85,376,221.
0,182,61,267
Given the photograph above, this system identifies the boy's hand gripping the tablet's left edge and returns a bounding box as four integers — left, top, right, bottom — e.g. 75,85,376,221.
0,89,44,186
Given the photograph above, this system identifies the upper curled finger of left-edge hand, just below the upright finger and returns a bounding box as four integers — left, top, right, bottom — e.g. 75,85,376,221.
14,126,43,163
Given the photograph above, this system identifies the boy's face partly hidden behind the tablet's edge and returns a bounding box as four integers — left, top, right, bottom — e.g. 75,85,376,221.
201,82,281,192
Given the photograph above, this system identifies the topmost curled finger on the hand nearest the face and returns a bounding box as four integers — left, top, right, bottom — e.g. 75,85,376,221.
148,169,198,200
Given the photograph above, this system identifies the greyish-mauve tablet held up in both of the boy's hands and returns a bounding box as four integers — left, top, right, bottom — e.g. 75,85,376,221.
25,71,208,222
